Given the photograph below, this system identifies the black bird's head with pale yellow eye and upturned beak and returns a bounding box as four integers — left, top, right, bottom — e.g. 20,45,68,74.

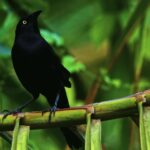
16,10,42,34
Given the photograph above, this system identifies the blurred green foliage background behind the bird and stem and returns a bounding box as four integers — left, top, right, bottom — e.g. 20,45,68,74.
0,0,150,150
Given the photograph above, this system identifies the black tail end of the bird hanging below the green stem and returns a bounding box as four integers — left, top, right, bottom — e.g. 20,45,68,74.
60,127,84,150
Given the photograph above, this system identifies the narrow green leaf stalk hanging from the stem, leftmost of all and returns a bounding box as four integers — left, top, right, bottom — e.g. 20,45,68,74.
11,118,20,150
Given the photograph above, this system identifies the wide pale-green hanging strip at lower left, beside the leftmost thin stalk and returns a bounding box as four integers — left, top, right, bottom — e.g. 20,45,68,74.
16,125,30,150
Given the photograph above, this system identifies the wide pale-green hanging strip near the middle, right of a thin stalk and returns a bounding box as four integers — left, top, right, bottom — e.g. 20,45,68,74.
91,120,102,150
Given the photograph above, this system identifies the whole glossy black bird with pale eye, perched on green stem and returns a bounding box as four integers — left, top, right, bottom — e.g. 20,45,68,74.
9,11,83,148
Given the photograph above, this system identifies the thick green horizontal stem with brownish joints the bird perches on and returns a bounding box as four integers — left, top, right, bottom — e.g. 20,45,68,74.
0,90,150,131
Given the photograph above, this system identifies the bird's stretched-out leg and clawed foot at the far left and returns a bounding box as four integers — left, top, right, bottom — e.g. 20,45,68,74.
2,98,35,119
